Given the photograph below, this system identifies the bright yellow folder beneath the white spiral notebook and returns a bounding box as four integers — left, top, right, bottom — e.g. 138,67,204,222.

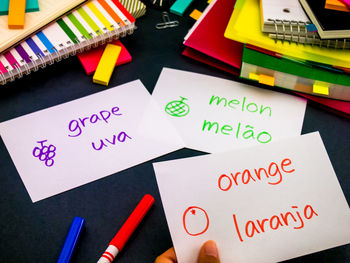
225,0,350,68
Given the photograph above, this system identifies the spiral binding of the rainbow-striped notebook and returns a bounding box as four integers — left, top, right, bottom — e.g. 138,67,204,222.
0,24,134,85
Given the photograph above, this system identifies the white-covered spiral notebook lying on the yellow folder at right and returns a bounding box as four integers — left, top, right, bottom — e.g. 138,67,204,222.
260,0,350,49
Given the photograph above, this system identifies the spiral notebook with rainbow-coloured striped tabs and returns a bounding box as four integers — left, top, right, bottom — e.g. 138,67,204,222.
0,0,135,85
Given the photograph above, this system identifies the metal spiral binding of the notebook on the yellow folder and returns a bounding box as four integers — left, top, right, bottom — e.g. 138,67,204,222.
268,19,350,49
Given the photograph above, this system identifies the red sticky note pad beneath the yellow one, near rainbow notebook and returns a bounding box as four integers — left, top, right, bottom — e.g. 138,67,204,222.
77,39,132,75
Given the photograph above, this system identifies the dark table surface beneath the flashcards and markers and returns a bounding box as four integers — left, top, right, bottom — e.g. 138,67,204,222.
0,0,350,263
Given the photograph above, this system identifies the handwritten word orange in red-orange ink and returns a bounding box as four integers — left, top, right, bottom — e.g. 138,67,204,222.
218,158,295,191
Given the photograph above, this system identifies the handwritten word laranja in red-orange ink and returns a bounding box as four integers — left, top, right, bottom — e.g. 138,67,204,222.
233,205,318,242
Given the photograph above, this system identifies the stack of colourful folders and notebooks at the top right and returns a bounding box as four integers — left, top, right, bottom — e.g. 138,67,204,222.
183,0,350,117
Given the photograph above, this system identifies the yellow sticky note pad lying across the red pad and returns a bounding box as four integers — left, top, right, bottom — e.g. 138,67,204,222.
93,44,122,86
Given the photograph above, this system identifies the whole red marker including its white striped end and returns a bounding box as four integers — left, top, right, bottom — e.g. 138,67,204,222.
97,194,154,263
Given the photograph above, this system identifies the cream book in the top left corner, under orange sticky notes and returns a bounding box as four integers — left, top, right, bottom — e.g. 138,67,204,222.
0,0,86,53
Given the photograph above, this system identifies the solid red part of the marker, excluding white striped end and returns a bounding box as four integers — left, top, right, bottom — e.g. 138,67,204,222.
110,194,154,251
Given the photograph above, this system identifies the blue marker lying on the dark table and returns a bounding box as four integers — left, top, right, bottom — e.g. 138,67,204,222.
57,217,85,263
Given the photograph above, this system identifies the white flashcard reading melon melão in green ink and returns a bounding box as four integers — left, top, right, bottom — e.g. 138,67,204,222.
152,68,306,153
